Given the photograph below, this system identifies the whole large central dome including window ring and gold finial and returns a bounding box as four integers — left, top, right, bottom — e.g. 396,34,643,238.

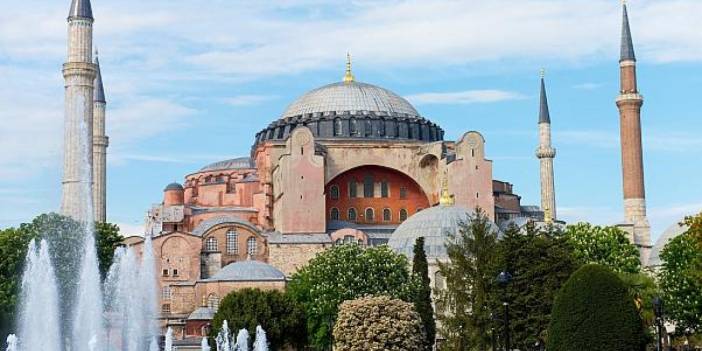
254,62,444,146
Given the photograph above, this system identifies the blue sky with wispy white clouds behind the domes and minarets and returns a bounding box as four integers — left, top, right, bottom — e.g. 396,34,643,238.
0,0,702,243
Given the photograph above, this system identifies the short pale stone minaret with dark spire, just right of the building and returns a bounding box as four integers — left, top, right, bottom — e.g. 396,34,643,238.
536,69,556,223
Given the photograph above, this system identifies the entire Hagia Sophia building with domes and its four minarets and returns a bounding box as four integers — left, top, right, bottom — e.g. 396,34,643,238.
52,0,673,342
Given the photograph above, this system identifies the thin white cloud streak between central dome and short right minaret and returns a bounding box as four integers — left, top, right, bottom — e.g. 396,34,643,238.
406,89,525,105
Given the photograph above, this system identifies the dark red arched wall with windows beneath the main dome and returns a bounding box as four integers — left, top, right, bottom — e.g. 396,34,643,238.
325,166,429,224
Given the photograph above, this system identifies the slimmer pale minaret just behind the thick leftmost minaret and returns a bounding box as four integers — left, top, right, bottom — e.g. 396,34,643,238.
93,50,109,222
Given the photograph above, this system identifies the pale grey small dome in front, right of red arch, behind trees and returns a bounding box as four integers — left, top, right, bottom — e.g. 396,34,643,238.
388,205,498,262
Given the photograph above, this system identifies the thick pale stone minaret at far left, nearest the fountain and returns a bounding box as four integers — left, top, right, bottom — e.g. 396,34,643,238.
61,0,96,221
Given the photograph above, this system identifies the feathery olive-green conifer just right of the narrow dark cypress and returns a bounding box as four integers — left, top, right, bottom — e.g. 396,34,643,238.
436,209,498,350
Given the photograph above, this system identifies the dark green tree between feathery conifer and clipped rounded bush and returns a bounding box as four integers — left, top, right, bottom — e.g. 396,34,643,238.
491,223,580,350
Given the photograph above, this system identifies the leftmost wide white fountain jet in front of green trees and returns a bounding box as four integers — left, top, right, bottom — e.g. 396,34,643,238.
18,240,61,351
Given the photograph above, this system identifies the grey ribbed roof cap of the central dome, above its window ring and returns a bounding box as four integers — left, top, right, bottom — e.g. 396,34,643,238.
282,81,419,118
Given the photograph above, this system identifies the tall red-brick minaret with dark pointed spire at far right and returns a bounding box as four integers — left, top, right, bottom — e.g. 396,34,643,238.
617,3,651,262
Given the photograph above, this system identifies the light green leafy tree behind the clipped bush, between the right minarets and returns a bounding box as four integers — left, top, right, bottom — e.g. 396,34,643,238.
565,223,641,273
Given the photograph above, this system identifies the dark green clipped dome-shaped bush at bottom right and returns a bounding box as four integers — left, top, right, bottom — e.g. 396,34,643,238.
548,265,645,351
